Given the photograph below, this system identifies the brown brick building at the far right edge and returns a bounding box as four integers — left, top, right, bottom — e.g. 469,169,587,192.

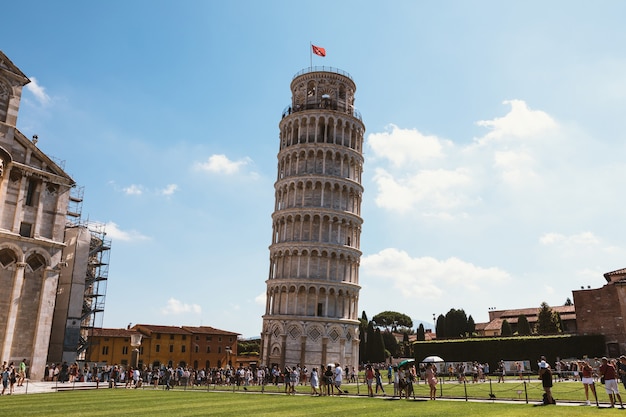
572,268,626,357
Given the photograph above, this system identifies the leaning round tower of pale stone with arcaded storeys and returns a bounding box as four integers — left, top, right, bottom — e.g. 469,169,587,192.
261,67,365,369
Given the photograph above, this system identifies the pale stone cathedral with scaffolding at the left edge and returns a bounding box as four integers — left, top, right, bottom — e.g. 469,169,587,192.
0,51,108,380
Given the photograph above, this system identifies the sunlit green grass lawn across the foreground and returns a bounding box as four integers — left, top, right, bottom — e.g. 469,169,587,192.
0,384,626,417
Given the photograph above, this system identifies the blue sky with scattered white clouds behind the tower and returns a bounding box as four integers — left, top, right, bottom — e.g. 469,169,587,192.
0,0,626,337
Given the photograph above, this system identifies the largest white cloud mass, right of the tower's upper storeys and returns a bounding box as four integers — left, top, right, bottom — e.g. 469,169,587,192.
367,100,567,219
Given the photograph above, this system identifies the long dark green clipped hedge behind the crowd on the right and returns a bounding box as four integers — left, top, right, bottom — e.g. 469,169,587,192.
413,335,606,370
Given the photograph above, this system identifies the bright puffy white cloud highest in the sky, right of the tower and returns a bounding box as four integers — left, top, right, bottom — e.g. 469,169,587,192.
476,100,557,144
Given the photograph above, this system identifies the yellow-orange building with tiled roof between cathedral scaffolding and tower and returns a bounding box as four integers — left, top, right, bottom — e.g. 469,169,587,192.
86,324,239,369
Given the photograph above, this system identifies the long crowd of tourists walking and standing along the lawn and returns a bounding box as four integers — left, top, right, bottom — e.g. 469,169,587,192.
9,356,626,408
